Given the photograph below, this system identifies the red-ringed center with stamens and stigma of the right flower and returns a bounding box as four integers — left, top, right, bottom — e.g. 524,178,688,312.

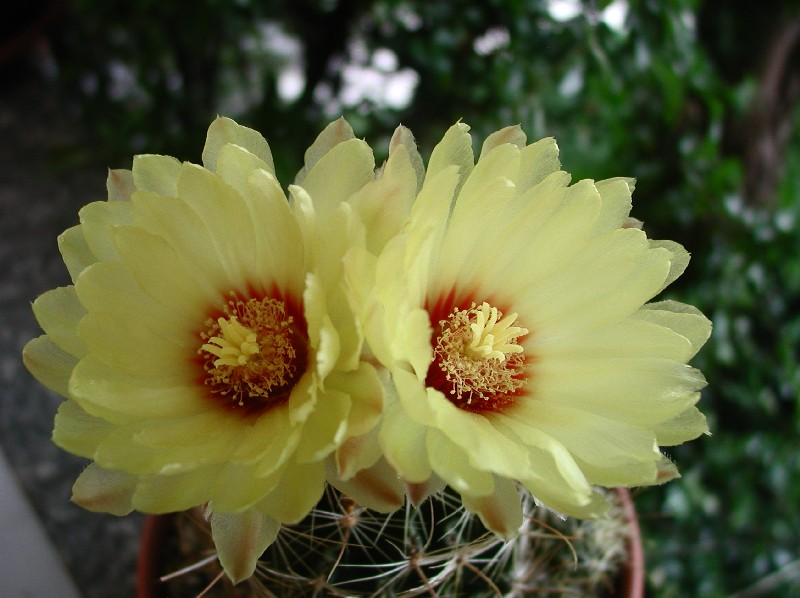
426,302,528,412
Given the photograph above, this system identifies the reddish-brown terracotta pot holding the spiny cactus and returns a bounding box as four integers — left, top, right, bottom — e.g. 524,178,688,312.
136,488,645,598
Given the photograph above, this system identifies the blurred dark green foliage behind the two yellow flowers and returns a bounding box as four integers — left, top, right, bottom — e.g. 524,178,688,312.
47,0,800,596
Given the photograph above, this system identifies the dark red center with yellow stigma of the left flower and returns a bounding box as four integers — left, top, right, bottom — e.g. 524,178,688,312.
197,293,307,413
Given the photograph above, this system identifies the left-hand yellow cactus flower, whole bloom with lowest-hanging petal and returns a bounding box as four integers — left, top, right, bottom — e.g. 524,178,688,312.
24,118,388,581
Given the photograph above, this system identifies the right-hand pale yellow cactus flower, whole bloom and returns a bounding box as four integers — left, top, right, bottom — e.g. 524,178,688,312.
360,123,711,538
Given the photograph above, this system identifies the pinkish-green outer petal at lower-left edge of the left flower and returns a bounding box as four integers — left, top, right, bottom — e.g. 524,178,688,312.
72,463,138,516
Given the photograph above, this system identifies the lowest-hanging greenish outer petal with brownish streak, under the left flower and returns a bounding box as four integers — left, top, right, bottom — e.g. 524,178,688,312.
209,509,281,584
